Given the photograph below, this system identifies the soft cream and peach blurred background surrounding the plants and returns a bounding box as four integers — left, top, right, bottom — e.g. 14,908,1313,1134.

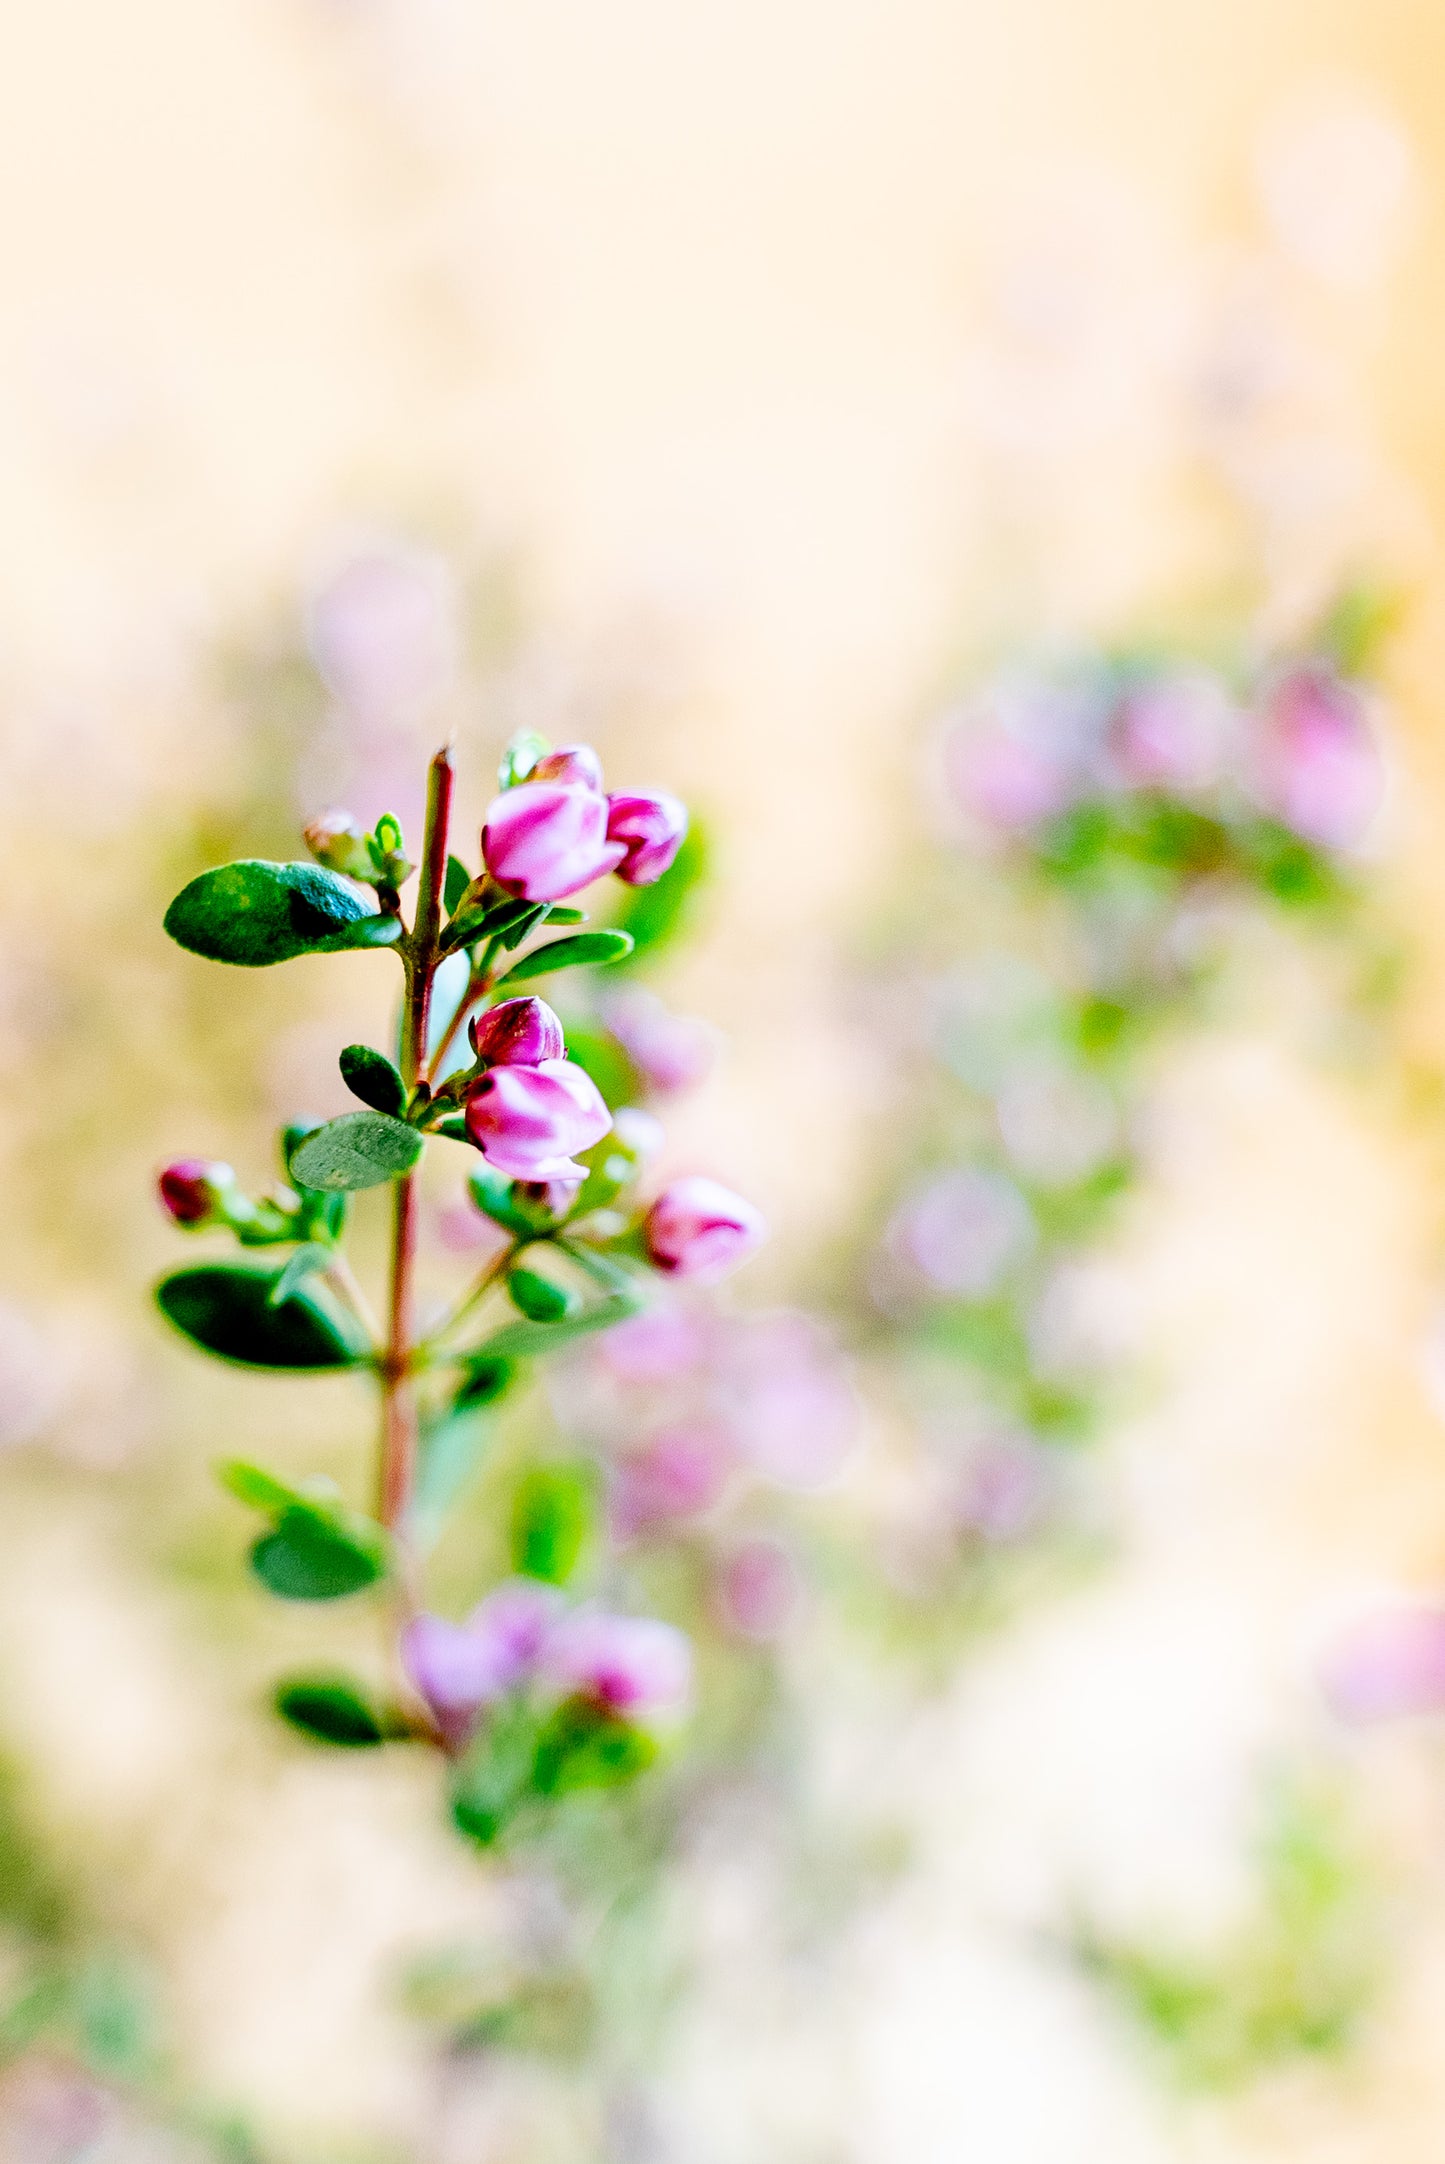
0,0,1445,2164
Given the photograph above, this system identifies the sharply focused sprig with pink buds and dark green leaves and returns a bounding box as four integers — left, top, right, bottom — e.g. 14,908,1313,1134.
158,736,764,1844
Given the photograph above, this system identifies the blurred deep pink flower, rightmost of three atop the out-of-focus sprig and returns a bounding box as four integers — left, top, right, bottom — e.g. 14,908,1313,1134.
1257,669,1384,848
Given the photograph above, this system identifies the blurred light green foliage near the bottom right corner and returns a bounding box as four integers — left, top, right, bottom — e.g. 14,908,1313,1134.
1073,1783,1382,2088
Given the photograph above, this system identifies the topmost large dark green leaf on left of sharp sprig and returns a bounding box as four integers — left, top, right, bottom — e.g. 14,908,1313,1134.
164,857,402,969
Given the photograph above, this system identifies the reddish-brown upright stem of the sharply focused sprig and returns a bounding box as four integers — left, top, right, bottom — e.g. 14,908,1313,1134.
379,744,452,1530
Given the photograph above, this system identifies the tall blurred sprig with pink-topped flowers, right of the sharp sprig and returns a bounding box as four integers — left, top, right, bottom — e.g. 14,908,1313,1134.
847,597,1384,1625
